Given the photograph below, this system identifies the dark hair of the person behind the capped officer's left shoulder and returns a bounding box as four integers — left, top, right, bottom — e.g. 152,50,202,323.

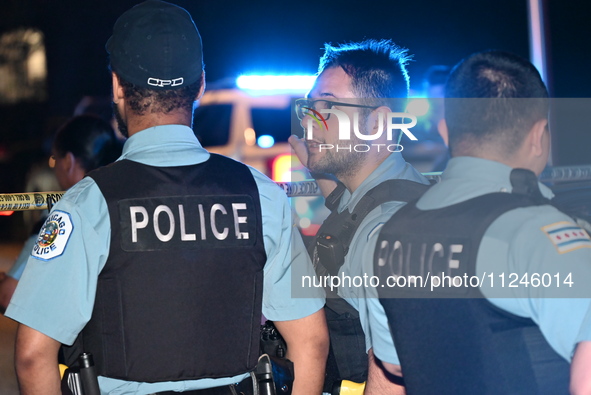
53,114,123,173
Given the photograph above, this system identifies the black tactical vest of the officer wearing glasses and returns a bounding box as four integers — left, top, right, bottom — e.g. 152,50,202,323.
309,179,429,392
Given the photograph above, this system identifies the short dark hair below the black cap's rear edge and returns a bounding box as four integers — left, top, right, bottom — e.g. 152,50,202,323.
115,71,202,115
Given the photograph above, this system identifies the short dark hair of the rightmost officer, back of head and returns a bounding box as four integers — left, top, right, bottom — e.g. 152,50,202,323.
445,51,548,154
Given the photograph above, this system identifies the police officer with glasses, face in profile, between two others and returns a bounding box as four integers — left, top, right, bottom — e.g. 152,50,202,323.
290,40,428,395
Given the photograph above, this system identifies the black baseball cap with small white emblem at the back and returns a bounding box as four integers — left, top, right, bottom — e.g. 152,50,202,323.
106,0,203,90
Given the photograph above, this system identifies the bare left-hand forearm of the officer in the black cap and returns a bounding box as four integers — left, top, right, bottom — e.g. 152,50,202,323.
15,324,61,395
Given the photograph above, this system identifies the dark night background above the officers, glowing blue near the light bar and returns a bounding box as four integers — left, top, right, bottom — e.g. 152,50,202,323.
0,0,591,238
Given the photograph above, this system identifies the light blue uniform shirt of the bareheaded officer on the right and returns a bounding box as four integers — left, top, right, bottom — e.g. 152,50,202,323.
374,157,591,364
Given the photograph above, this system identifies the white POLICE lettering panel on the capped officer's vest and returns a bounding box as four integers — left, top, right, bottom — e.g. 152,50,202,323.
119,195,256,251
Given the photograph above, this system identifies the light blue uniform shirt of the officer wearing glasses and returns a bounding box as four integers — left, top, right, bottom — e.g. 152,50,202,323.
338,152,429,362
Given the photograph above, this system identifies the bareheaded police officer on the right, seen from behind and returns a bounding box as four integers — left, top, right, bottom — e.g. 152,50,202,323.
375,51,591,395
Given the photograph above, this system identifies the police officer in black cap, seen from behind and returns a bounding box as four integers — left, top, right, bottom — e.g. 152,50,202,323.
7,0,328,395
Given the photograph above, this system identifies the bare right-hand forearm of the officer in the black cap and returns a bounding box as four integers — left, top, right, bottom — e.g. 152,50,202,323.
274,309,329,395
